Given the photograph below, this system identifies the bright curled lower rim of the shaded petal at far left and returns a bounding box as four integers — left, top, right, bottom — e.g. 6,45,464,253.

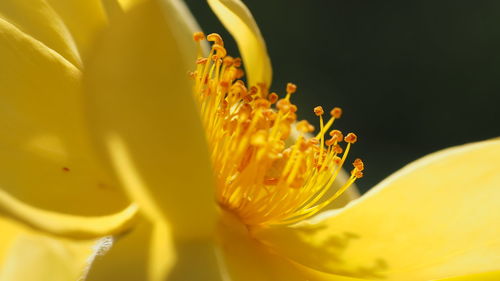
0,190,137,239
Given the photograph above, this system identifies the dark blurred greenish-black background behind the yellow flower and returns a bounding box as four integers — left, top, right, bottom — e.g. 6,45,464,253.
187,0,500,191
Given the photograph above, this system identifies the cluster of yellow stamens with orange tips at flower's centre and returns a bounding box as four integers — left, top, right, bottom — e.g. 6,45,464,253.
191,32,364,225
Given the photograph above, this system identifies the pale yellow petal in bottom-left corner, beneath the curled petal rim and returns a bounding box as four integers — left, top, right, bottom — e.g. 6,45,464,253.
0,217,108,281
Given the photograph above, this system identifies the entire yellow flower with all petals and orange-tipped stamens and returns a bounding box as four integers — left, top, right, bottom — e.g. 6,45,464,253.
0,0,500,281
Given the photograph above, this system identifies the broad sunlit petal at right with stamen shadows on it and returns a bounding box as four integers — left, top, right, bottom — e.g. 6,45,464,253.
256,139,500,281
